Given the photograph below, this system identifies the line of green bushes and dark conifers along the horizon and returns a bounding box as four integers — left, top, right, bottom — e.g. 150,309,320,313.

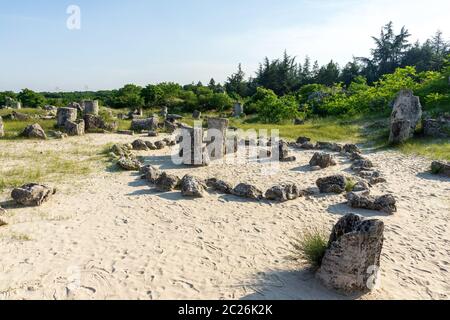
0,22,450,122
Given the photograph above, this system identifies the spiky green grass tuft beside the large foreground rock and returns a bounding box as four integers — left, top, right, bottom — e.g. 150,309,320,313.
292,230,328,268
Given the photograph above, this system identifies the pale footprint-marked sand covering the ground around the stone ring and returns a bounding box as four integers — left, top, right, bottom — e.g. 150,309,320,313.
0,135,450,299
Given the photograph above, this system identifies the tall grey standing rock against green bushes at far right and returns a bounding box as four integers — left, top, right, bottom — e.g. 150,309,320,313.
389,90,422,144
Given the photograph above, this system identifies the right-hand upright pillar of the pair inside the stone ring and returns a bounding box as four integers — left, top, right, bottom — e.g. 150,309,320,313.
207,118,229,160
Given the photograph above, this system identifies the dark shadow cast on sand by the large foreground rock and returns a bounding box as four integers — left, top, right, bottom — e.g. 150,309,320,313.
241,269,361,300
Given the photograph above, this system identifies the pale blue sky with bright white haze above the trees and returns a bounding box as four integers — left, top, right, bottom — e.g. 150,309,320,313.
0,0,450,91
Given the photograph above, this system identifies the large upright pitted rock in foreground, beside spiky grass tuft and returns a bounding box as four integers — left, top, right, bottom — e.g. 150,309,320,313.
317,214,384,293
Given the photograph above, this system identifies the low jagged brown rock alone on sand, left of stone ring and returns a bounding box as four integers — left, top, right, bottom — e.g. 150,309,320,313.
11,183,56,206
